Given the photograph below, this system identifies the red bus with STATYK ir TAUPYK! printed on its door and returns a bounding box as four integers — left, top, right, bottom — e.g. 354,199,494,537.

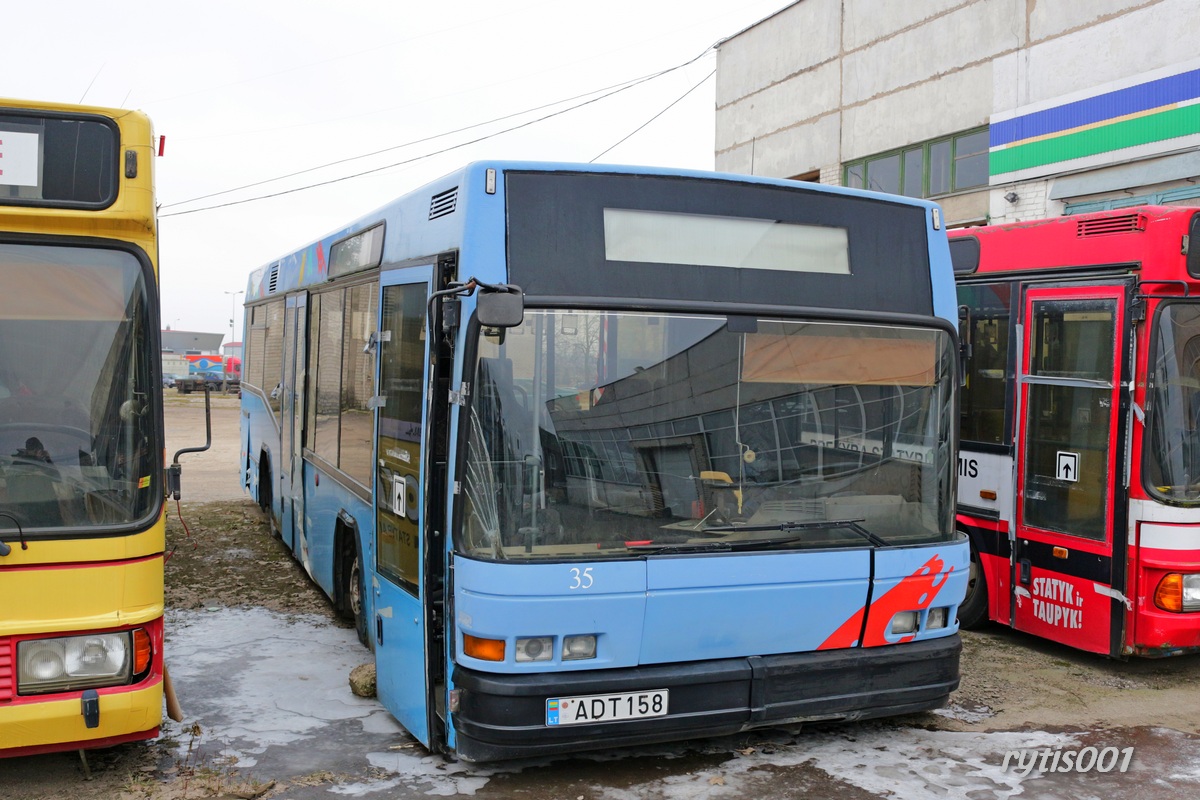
950,206,1200,657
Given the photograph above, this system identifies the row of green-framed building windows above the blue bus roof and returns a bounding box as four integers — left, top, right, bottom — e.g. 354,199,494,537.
842,128,988,198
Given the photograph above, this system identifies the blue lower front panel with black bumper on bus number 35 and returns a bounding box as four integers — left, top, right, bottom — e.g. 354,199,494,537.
450,540,967,760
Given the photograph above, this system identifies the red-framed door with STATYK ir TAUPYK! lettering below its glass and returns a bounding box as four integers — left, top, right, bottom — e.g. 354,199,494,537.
1013,285,1128,655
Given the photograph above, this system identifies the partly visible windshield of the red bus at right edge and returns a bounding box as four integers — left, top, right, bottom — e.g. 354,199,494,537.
1145,301,1200,503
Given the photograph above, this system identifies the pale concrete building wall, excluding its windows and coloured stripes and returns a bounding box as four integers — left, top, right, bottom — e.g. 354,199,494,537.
716,0,1200,224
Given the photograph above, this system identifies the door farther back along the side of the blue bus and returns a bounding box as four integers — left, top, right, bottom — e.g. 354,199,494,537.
276,294,312,561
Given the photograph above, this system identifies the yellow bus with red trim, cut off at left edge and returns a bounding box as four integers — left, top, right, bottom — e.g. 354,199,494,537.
0,100,164,757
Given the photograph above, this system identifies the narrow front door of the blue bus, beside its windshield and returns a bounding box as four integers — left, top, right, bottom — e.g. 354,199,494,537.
371,267,438,746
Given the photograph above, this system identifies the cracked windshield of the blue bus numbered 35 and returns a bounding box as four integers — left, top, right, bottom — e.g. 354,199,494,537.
457,309,954,559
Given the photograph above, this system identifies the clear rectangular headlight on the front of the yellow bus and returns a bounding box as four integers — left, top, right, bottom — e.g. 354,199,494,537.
17,631,132,694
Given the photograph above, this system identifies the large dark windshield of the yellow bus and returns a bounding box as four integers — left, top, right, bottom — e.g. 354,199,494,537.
0,245,162,536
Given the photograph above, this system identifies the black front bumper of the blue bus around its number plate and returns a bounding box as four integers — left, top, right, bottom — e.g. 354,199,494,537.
451,633,962,762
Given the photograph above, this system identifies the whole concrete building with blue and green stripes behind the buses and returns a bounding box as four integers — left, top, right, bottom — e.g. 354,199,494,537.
716,0,1200,225
